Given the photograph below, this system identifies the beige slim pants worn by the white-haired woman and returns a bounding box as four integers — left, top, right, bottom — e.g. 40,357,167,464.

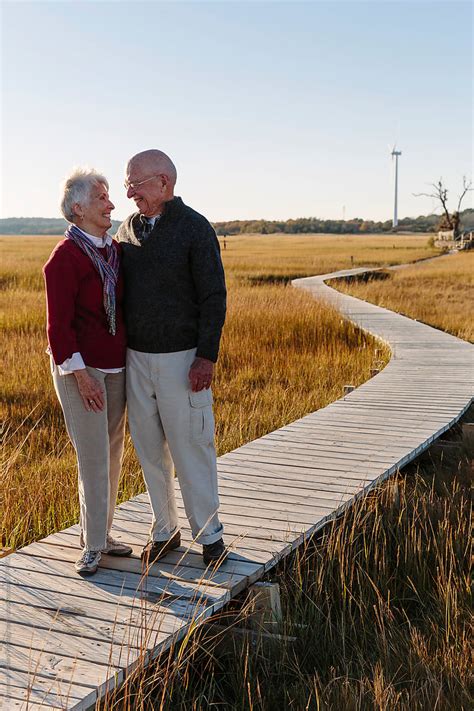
53,366,125,550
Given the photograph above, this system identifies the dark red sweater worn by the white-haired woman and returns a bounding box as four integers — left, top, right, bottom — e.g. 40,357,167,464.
43,239,126,368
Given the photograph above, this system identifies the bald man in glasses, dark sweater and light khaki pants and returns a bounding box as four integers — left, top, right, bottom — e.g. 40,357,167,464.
117,150,226,565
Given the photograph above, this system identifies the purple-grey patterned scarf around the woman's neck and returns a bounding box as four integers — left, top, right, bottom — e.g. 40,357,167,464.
64,225,120,336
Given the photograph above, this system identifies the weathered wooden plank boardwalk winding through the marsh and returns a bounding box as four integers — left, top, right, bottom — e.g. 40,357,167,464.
0,269,474,711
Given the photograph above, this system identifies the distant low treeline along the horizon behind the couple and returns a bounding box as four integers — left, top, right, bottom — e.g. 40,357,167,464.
0,209,474,235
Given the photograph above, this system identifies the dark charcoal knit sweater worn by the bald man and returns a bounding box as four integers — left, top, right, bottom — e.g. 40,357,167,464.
117,197,226,362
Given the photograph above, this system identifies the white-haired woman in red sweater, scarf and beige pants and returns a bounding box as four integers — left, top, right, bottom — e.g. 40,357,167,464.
43,169,132,575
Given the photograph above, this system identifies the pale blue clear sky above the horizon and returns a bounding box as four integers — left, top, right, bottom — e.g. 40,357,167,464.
0,0,474,221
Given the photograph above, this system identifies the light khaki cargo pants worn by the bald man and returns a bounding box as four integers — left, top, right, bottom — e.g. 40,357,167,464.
127,348,223,544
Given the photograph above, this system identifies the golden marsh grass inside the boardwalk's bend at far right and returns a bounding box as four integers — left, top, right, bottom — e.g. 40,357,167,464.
334,251,474,343
